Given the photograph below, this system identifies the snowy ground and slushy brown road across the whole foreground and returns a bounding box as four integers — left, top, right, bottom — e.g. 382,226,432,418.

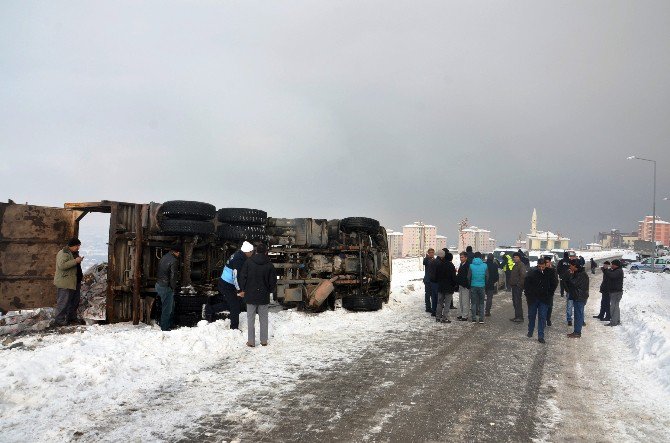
0,260,670,441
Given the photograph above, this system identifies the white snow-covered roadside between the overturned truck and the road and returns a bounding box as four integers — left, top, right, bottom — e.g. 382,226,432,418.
0,259,425,441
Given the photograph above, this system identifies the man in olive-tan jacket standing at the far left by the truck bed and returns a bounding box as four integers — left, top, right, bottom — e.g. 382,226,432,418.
54,238,84,326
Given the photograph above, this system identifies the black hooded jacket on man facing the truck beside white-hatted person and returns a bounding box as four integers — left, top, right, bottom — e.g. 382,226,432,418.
237,254,277,305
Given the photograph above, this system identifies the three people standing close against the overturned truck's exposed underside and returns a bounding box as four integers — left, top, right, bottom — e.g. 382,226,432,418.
156,241,277,348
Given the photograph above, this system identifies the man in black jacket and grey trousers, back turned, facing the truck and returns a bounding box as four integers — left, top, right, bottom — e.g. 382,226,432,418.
239,243,277,348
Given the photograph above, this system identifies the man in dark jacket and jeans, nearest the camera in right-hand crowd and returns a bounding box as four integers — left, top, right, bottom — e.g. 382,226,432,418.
524,257,551,343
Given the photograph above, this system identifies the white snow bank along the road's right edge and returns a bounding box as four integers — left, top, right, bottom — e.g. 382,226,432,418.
616,271,670,392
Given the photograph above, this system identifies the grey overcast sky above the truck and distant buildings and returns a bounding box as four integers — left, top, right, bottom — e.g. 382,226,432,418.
0,0,670,246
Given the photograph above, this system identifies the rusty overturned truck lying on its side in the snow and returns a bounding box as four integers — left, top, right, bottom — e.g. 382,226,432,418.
0,201,391,325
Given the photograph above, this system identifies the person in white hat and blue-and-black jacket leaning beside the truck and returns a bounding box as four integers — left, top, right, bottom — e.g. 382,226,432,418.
205,241,254,329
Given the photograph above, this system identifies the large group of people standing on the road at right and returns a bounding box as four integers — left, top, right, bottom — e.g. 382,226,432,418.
423,250,623,343
